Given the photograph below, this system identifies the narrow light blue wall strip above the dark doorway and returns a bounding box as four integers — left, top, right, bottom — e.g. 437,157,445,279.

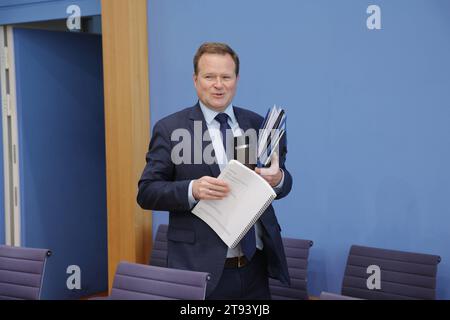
0,0,101,25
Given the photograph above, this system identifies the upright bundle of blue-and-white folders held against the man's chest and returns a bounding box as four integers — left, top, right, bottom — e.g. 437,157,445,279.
257,105,286,168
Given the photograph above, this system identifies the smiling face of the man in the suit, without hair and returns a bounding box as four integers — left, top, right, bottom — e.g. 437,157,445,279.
194,53,239,112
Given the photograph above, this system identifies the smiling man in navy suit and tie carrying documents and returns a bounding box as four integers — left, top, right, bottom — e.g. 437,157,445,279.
137,43,292,299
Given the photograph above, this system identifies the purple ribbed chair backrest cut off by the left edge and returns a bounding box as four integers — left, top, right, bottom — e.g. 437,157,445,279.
0,245,51,300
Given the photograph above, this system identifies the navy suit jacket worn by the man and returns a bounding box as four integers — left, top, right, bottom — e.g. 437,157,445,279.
137,103,292,295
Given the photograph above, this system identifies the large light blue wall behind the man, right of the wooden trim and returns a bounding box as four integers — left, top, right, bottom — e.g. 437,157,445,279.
148,0,450,299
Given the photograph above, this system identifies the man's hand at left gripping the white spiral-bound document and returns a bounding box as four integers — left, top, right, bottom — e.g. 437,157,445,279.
192,176,230,200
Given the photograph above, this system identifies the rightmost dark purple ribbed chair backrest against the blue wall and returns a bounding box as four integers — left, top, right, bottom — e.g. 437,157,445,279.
342,245,441,300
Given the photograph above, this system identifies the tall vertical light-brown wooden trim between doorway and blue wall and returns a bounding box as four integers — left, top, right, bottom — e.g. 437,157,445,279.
101,0,152,289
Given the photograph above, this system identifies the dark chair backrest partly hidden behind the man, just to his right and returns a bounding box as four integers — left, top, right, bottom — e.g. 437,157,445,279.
269,238,313,300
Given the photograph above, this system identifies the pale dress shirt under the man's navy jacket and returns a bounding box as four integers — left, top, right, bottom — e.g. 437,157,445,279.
188,101,284,258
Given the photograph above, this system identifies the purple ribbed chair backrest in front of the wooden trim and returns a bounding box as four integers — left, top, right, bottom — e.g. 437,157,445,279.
109,262,209,300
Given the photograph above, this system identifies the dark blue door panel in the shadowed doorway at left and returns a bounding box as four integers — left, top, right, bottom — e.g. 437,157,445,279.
14,29,108,299
